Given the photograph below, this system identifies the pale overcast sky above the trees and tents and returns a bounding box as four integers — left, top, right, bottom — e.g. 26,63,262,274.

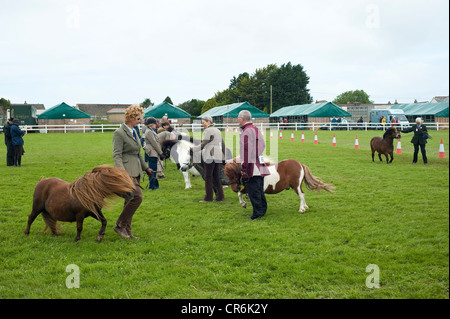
0,0,449,108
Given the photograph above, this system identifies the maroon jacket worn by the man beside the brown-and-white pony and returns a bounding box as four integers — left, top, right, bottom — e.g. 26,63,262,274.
240,123,270,178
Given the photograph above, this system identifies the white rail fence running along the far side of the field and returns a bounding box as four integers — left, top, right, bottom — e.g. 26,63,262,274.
22,123,449,133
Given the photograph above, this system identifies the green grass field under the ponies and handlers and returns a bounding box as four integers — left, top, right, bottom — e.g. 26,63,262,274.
0,131,449,299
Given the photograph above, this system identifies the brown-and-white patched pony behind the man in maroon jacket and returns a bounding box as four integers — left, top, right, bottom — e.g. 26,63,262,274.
225,159,335,213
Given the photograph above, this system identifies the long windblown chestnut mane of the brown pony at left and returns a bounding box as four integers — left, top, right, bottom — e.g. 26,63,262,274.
69,165,135,218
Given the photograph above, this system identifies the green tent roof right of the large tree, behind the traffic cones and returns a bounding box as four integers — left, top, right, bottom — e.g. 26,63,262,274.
270,102,352,117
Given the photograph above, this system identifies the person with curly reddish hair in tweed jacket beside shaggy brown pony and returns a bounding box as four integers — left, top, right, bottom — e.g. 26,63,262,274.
113,104,153,239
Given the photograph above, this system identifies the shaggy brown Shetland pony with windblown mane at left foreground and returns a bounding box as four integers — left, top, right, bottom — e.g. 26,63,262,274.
23,165,135,241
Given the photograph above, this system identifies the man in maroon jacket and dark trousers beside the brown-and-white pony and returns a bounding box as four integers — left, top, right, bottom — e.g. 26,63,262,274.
238,110,270,220
